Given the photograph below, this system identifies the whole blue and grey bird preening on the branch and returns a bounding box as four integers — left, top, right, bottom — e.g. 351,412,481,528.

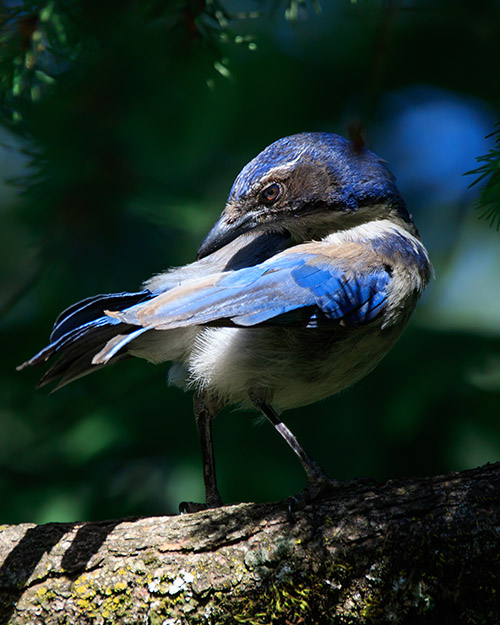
18,132,433,512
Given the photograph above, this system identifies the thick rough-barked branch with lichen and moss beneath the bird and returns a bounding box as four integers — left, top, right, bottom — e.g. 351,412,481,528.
0,464,500,625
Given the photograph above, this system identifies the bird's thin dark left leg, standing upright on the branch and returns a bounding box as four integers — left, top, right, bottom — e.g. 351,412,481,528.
179,393,222,512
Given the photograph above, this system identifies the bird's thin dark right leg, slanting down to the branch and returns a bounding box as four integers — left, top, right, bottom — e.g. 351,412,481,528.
251,397,339,508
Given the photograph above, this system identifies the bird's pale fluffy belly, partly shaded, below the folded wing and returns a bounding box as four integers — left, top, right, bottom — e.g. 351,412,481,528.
182,324,403,410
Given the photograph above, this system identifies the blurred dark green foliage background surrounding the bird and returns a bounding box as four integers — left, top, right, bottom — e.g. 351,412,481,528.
0,0,500,522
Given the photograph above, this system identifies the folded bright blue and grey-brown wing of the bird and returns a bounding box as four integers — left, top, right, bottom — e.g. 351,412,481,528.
112,253,391,329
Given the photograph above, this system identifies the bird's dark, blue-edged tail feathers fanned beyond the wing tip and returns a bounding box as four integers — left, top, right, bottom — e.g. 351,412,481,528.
17,291,154,389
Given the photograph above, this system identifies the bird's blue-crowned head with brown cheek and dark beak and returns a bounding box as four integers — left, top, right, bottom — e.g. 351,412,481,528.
198,132,416,258
